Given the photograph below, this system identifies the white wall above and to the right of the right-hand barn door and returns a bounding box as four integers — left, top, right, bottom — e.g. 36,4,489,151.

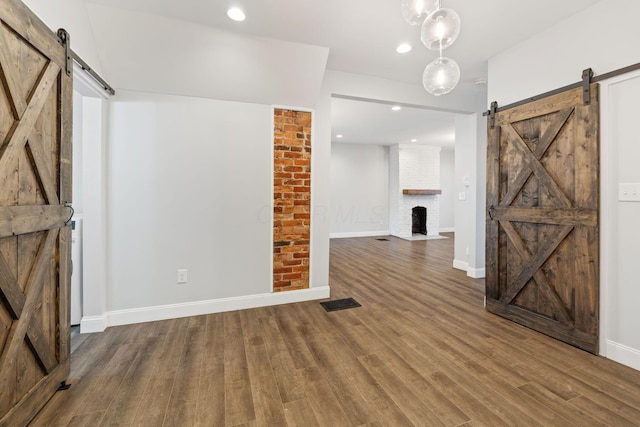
488,0,640,369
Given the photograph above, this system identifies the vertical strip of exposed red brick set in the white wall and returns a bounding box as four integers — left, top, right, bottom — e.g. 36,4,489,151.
273,109,311,292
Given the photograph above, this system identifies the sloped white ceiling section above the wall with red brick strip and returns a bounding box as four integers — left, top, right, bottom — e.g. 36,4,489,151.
87,4,329,108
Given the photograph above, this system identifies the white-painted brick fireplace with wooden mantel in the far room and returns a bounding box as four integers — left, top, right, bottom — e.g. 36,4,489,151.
389,144,440,240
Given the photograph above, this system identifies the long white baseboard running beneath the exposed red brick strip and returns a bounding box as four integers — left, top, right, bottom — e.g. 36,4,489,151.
106,286,330,326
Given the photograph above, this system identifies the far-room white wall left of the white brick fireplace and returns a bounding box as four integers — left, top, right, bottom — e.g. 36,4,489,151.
330,143,389,237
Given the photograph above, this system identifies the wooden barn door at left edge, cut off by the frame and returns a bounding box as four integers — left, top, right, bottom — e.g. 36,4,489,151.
0,0,72,426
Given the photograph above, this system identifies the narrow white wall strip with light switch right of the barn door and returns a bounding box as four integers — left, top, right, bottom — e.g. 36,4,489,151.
600,71,640,370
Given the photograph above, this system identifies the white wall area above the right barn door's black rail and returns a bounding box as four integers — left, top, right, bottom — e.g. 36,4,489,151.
487,0,640,107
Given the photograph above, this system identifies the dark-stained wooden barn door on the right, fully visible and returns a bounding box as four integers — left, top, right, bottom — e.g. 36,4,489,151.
486,84,599,353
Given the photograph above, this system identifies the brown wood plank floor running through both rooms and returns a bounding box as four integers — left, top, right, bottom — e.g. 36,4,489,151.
32,237,640,427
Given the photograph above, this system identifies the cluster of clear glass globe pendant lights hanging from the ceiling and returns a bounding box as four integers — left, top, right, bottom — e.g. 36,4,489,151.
402,0,461,96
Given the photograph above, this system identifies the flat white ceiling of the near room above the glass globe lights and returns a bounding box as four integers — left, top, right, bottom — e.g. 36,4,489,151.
85,0,598,84
